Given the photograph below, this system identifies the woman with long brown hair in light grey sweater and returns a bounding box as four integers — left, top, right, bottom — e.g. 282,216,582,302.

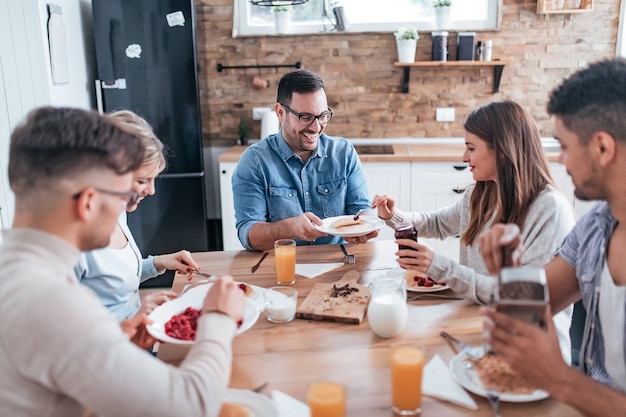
372,101,576,356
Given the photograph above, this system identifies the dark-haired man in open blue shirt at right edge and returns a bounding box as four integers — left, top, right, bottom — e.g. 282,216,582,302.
479,58,626,417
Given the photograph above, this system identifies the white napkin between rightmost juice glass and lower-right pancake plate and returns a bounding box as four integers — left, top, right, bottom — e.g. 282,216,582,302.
422,355,478,410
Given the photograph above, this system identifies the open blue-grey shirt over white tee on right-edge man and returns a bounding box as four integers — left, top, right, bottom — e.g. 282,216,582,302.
559,202,626,387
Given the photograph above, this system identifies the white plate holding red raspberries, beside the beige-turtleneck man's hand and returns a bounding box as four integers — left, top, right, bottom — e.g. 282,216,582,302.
146,283,259,345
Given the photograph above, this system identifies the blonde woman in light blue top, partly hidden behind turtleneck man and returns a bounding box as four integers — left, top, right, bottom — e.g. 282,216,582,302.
75,110,199,321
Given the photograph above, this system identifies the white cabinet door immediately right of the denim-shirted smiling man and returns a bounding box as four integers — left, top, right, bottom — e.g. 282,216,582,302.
361,162,411,240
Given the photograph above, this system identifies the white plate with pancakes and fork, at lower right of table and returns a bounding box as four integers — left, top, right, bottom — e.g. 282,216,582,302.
450,352,549,403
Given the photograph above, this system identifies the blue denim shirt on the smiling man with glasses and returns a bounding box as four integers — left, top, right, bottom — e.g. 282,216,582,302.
232,131,370,250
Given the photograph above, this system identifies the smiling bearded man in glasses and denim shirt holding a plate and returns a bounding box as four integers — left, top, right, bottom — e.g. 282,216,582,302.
232,70,378,250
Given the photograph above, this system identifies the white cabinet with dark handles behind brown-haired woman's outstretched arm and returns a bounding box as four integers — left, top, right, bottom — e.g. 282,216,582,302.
410,162,474,262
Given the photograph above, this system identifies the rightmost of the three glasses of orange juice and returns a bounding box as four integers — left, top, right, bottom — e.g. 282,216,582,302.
391,342,425,416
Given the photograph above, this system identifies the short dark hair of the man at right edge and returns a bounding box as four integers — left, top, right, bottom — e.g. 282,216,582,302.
548,58,626,144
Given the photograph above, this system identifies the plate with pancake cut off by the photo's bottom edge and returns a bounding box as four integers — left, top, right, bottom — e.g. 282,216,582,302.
218,388,278,417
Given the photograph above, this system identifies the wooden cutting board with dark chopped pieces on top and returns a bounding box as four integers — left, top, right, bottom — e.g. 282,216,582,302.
296,271,370,324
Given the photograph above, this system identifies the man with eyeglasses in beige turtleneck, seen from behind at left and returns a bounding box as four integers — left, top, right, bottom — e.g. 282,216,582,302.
0,107,244,417
